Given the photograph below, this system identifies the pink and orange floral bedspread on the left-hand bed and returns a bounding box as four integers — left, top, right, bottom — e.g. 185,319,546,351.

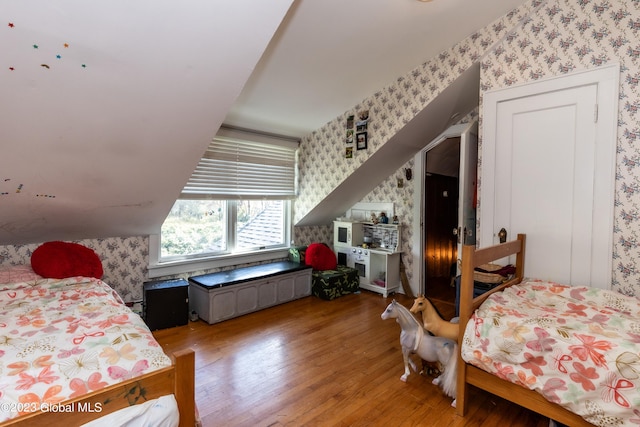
0,277,171,421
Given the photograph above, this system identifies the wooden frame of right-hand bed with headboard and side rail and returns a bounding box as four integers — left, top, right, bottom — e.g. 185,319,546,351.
456,234,593,427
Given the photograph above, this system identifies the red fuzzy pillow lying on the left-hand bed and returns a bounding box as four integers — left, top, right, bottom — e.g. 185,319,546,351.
31,242,104,279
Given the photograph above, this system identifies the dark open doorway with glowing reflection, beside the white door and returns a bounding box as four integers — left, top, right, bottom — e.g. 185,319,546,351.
424,137,460,305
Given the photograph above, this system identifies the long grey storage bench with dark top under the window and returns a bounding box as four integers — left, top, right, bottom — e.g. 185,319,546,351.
189,261,312,324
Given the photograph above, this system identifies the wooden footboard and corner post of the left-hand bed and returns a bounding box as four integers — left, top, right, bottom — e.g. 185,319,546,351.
0,349,196,427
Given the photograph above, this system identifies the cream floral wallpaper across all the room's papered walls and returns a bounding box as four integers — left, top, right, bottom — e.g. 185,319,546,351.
0,0,640,301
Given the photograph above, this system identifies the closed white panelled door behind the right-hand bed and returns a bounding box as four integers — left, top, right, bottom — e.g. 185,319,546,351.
494,86,596,283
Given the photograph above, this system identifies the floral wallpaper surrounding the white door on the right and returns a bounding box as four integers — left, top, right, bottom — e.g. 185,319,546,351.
479,0,640,296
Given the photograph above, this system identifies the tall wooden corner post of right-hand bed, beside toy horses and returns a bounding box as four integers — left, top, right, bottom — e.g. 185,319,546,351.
456,245,476,416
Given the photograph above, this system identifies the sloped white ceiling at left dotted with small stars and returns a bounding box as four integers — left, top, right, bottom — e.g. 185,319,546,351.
0,0,293,244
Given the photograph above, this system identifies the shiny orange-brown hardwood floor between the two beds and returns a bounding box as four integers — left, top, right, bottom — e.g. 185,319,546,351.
154,291,548,427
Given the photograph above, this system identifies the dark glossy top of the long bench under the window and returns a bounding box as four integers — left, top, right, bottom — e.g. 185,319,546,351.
189,261,311,289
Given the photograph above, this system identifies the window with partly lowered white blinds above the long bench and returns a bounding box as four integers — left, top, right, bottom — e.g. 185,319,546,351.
159,127,297,262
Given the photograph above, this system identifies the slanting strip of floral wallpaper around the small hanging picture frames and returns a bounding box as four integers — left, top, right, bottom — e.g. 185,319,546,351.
294,2,539,226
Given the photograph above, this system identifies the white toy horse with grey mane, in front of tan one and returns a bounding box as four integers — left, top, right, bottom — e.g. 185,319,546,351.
380,300,458,407
